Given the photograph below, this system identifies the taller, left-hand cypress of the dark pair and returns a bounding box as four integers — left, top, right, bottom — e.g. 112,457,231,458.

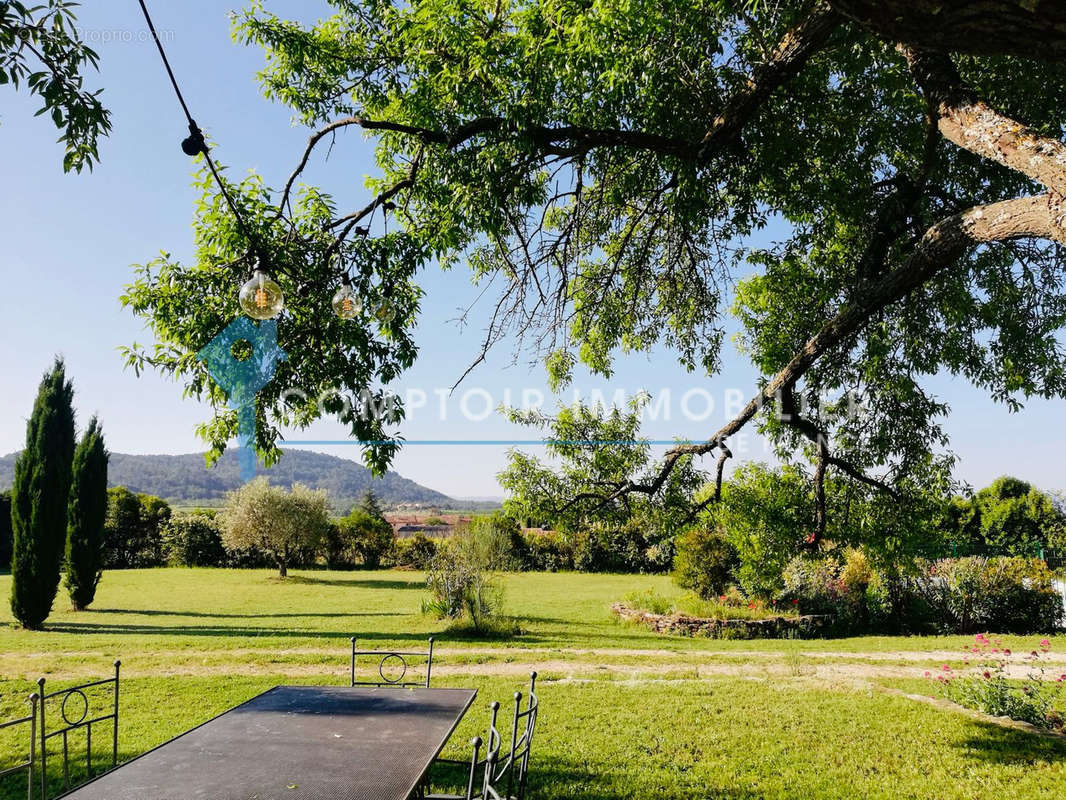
11,358,75,629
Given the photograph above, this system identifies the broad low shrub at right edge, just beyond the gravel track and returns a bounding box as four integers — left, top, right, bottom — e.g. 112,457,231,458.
921,558,1063,634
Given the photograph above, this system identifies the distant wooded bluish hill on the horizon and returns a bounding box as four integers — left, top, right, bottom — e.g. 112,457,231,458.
0,450,456,511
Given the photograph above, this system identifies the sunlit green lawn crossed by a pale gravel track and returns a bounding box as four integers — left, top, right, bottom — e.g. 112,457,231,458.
0,569,1066,800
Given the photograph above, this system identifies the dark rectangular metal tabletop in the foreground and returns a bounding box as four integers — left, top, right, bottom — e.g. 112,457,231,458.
55,686,477,800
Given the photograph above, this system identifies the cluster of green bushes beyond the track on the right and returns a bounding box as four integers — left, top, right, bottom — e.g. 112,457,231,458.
674,464,1063,634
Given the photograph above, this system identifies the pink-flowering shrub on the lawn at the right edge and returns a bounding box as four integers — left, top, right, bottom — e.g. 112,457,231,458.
925,634,1066,730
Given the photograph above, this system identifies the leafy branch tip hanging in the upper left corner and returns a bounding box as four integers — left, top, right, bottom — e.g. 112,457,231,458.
0,0,111,172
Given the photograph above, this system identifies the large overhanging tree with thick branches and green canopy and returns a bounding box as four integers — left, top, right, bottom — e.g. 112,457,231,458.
126,0,1066,532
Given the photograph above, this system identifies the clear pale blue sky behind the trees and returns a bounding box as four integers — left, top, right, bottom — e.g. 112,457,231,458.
0,0,1066,496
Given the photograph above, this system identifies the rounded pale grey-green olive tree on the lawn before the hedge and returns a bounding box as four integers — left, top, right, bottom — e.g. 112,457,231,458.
220,477,329,578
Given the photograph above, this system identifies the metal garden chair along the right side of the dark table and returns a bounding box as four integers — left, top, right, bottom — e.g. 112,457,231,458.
422,672,539,800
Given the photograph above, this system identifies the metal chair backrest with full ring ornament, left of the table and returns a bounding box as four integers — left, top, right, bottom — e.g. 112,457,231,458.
37,661,122,800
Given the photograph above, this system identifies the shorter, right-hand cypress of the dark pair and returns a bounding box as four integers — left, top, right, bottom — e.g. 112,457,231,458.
66,417,108,611
